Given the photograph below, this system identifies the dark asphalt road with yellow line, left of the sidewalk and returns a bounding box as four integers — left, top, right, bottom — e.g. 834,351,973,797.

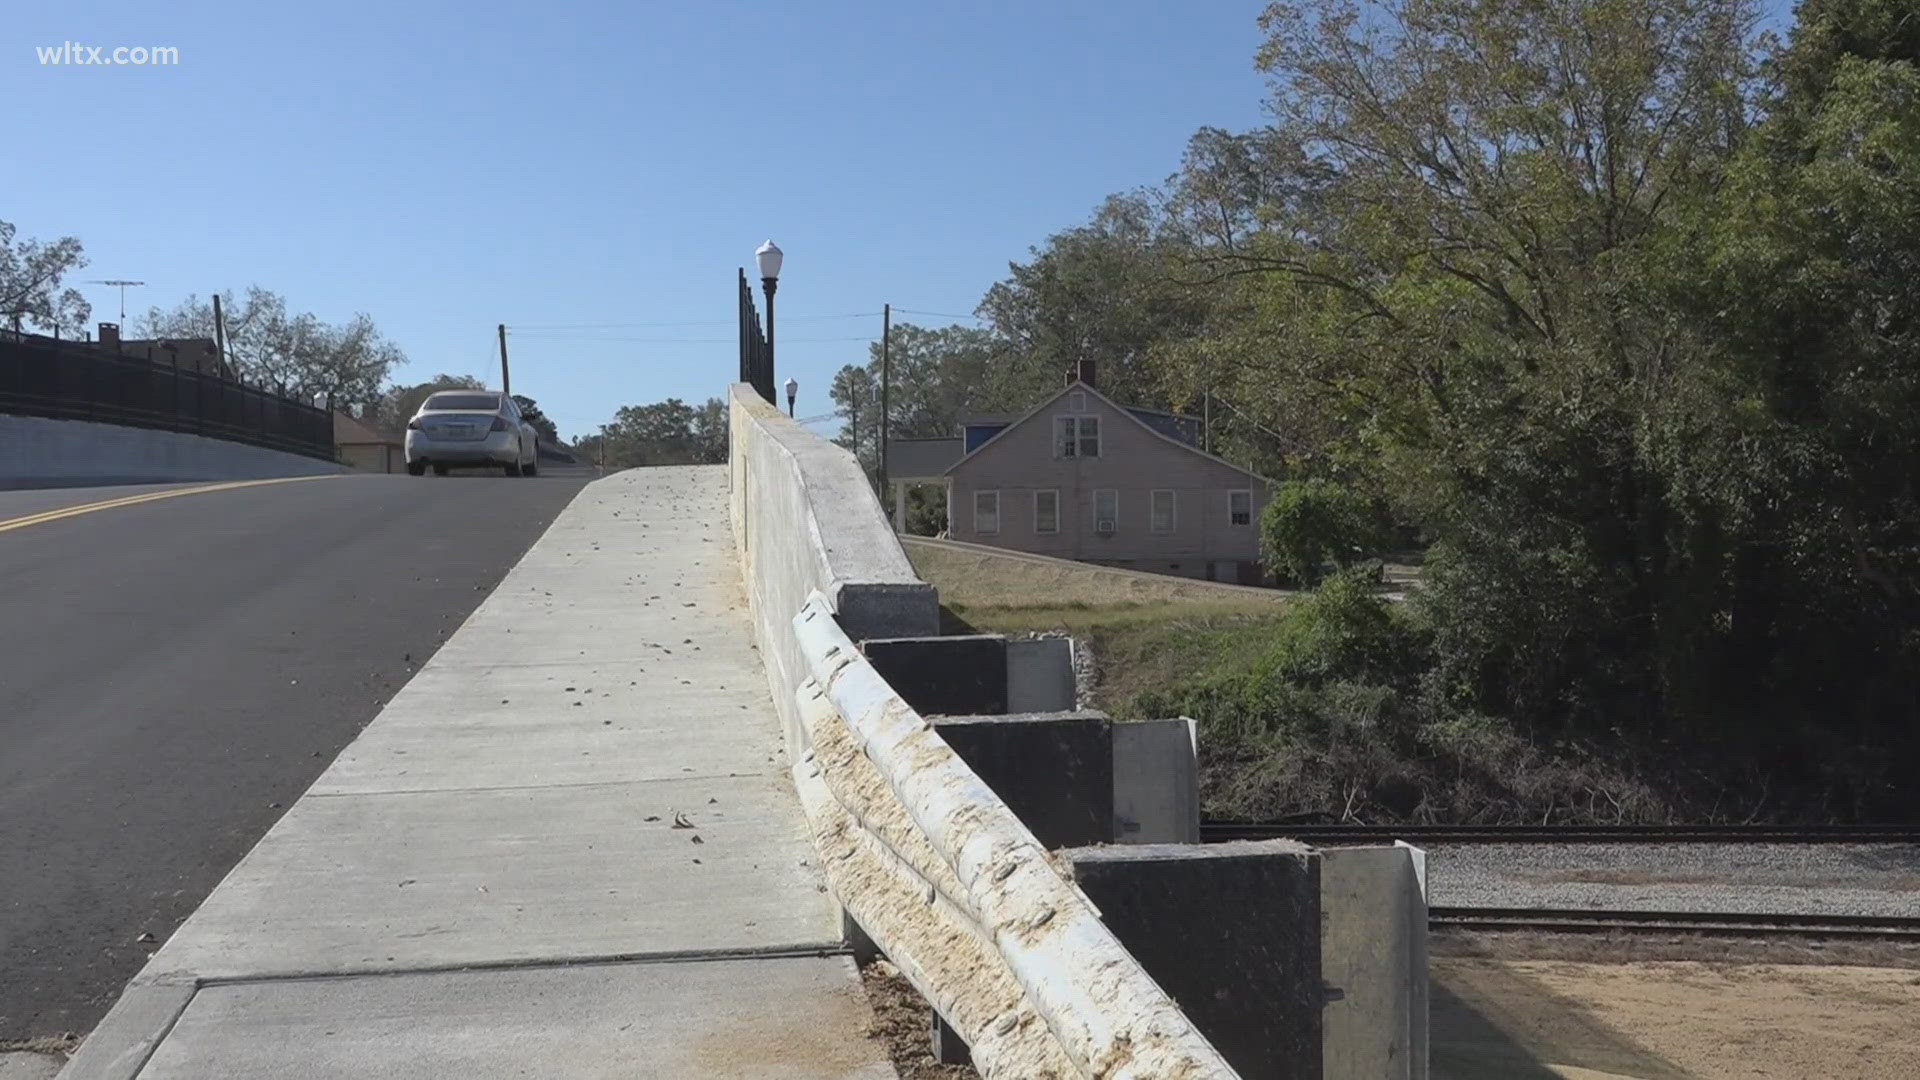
0,475,586,1042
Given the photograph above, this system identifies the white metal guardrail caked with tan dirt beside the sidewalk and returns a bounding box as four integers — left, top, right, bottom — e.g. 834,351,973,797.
793,592,1236,1080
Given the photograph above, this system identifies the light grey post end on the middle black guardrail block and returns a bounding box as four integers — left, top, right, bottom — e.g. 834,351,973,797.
1114,717,1200,844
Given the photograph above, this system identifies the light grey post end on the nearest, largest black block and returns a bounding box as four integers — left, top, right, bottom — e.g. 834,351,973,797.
1321,844,1427,1080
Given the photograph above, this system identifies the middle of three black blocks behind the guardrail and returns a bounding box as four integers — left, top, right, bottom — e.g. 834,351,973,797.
933,713,1114,847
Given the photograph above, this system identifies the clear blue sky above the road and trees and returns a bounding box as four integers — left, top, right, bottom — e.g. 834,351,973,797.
0,0,1784,436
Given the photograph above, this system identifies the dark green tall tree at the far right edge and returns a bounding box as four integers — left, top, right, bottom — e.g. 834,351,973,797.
1659,0,1920,803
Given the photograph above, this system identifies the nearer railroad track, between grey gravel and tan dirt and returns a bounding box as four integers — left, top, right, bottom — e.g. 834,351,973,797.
1427,907,1920,940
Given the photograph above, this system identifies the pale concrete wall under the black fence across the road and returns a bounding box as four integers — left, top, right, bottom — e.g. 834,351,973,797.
0,415,346,488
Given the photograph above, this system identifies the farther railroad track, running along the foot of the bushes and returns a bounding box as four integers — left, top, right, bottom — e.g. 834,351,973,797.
1200,822,1920,846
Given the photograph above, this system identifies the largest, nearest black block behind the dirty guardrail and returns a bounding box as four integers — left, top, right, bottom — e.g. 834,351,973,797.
1064,840,1320,1080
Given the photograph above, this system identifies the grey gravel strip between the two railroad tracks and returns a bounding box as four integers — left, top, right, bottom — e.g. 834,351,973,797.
1427,844,1920,917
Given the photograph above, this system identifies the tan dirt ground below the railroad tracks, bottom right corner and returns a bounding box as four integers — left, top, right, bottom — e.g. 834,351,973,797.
1428,957,1920,1080
